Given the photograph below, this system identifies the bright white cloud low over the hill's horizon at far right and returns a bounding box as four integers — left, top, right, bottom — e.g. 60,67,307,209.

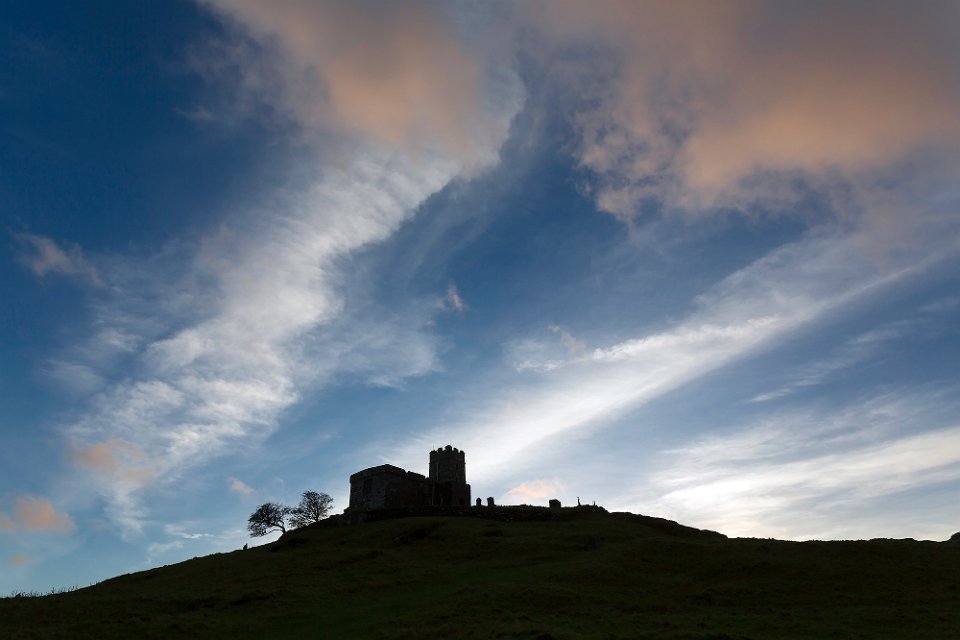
644,392,960,538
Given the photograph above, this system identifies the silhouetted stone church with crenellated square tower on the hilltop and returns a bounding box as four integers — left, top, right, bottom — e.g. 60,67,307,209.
347,445,470,512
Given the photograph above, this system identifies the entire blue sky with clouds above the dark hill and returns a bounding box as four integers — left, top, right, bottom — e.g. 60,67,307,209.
0,0,960,595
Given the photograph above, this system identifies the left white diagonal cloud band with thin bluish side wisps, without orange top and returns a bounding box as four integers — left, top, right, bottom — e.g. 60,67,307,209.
66,94,512,532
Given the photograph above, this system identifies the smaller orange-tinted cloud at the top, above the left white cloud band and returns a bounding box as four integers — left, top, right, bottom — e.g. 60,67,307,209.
201,0,487,153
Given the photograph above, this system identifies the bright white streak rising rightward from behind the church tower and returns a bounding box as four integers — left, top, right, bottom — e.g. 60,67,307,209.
397,225,955,482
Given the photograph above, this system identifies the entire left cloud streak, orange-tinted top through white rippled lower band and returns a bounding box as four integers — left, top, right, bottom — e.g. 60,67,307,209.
56,2,519,532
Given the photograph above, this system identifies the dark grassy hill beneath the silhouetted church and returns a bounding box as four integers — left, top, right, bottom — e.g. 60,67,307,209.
0,507,960,640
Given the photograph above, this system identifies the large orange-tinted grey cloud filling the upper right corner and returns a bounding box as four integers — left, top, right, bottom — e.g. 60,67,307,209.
541,1,960,216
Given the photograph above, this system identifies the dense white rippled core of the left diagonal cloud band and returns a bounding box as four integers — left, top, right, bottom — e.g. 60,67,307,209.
60,151,464,530
